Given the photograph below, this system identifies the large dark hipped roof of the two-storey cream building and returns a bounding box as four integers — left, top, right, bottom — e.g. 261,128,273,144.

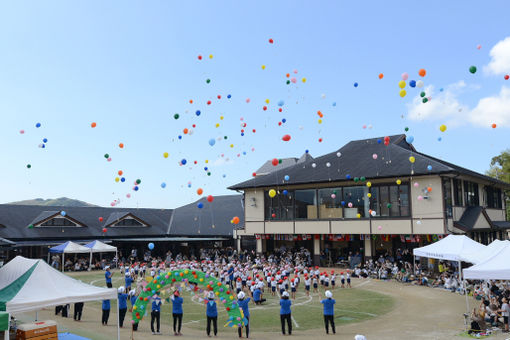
229,134,510,190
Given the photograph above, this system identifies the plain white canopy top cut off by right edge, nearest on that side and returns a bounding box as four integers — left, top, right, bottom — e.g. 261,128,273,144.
464,241,510,280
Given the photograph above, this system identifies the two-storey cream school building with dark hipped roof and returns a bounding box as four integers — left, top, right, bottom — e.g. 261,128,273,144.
229,135,510,263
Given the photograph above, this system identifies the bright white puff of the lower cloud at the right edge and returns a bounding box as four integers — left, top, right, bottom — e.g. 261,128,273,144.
469,86,510,127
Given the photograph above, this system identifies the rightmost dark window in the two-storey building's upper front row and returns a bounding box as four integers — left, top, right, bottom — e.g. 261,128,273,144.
370,184,409,217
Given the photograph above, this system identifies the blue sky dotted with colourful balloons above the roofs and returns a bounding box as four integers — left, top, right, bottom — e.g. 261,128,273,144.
0,1,510,208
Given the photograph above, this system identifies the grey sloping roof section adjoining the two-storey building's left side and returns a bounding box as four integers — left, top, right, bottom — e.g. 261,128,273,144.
167,195,244,236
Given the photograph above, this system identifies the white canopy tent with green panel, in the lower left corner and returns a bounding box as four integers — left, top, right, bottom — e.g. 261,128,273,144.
0,256,120,339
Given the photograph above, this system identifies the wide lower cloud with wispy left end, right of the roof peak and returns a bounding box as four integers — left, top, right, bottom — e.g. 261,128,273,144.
408,81,510,128
